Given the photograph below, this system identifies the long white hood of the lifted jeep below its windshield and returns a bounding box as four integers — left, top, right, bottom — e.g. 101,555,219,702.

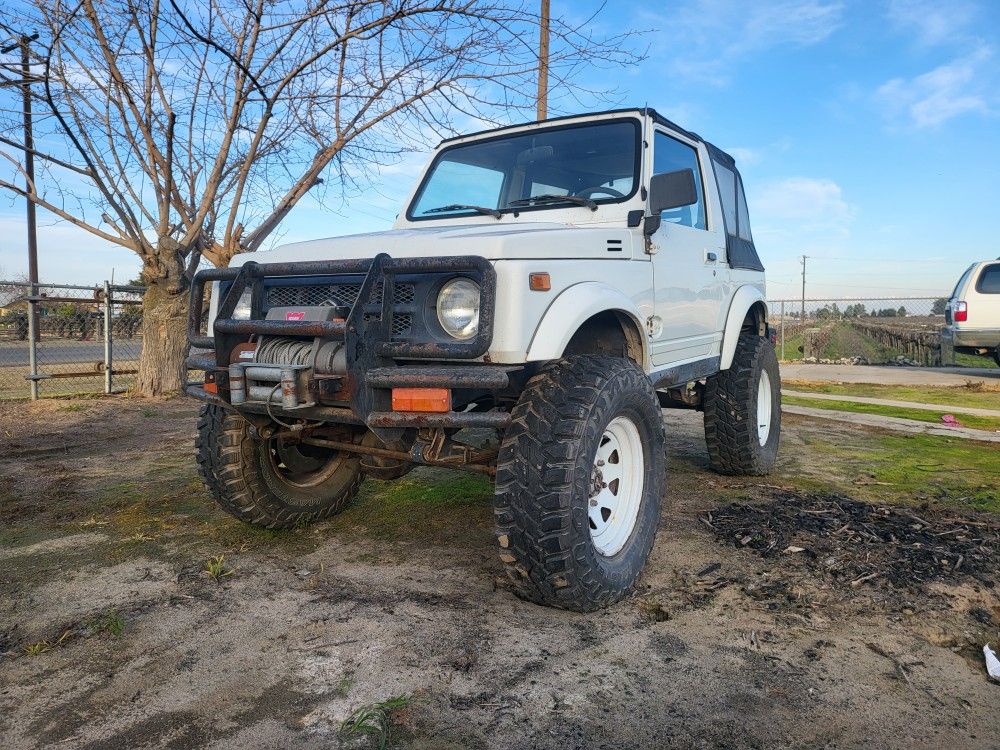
232,220,633,266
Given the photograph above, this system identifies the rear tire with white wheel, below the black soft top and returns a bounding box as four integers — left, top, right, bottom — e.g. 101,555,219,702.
704,334,781,476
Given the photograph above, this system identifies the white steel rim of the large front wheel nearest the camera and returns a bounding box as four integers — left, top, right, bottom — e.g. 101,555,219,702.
588,418,648,557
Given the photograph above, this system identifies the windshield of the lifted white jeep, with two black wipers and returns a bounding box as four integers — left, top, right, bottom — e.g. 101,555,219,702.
406,119,639,221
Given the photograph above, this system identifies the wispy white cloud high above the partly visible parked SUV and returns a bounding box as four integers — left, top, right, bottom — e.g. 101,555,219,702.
875,45,993,128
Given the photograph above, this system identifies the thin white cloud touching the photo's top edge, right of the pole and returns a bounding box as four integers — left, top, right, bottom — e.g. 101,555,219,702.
640,0,844,86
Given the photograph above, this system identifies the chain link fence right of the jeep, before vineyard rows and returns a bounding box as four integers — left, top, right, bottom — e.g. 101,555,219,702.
768,297,996,368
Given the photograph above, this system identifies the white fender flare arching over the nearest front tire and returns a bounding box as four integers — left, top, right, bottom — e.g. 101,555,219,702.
527,281,649,370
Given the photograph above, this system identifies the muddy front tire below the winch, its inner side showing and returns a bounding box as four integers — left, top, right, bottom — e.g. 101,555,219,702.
195,404,364,529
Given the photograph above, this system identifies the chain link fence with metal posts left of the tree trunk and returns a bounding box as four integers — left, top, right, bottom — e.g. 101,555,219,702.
0,281,144,400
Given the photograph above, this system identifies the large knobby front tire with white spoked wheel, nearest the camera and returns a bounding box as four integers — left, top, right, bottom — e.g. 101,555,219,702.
494,356,666,612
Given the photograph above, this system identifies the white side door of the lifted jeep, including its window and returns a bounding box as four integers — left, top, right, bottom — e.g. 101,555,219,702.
651,129,729,366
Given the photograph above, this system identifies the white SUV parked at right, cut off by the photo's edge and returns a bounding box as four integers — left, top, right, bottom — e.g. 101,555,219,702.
941,258,1000,365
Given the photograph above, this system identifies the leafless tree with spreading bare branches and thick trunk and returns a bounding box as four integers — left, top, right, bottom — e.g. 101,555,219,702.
0,0,636,395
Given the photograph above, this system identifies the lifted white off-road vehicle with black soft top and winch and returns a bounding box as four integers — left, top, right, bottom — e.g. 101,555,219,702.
187,109,780,610
